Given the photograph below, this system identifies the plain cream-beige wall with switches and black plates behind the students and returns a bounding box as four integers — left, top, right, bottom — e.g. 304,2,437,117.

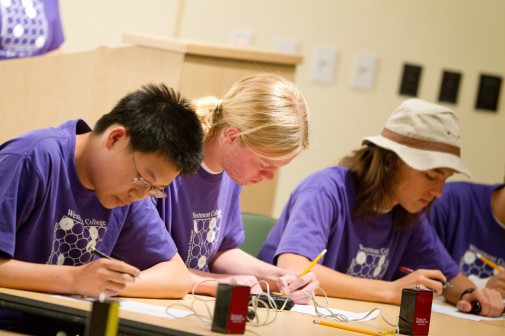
60,0,505,216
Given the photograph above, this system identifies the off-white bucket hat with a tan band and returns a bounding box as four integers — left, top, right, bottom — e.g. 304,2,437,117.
363,98,471,177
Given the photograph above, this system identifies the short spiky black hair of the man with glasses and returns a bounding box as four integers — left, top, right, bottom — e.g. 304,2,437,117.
93,84,203,174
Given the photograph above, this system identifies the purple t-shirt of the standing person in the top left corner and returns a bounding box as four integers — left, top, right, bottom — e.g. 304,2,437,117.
0,0,65,59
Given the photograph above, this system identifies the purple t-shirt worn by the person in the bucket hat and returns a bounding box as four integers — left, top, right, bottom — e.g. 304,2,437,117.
258,167,458,280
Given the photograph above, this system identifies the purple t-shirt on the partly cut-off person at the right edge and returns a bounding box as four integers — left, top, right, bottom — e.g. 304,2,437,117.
430,182,505,278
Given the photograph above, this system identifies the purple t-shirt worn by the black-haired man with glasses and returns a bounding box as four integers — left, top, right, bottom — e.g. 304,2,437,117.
0,120,177,329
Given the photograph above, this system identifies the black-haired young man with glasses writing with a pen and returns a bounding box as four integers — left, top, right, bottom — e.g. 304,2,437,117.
0,85,203,331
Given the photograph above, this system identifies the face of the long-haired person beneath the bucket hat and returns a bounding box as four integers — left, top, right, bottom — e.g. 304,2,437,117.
392,160,454,213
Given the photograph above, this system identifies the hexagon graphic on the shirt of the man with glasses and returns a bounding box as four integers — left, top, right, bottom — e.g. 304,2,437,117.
47,216,107,265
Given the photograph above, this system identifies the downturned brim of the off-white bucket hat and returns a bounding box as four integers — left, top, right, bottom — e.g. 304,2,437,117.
362,135,472,178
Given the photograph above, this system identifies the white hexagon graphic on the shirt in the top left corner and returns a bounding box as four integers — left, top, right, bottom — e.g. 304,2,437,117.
0,0,49,54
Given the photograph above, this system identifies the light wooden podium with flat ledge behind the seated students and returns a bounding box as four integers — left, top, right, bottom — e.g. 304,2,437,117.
0,33,303,215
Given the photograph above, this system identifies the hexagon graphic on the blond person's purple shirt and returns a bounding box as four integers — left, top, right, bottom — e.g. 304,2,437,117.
186,211,222,272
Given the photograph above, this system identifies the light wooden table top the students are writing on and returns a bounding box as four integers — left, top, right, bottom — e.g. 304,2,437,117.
0,288,505,336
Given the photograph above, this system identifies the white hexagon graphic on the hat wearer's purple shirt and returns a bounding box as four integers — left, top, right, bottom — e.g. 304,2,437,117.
347,244,389,279
